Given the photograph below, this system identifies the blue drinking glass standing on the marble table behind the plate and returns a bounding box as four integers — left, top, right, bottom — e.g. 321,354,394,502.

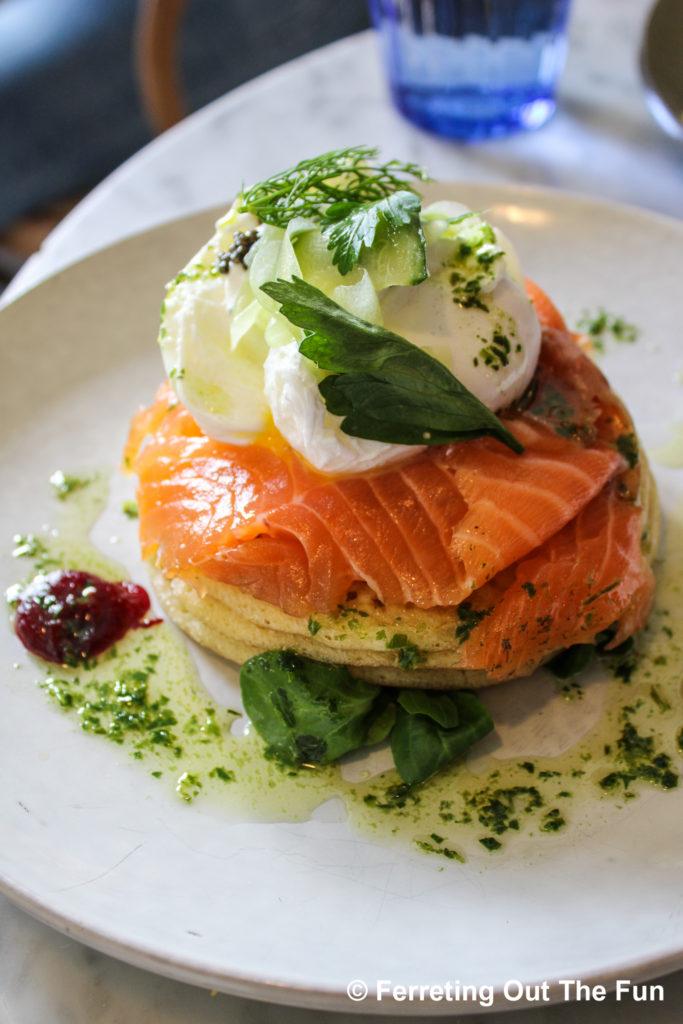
369,0,570,141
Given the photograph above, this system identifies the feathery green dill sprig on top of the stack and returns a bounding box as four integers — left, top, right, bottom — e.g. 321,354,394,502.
240,145,428,227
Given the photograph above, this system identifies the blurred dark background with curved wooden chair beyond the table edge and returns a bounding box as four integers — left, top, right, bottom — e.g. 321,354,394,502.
0,0,370,287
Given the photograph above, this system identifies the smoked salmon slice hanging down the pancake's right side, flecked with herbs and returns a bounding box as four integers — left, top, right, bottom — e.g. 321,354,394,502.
461,480,654,681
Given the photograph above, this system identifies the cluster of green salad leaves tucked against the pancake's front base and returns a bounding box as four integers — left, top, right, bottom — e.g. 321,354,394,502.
240,650,494,785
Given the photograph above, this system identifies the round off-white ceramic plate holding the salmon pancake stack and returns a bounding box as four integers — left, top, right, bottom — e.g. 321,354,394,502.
0,186,683,1013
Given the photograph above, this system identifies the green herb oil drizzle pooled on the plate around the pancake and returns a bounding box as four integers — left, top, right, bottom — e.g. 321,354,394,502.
7,474,683,869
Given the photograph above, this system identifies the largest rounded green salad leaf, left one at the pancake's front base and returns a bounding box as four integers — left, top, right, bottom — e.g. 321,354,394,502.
240,650,378,765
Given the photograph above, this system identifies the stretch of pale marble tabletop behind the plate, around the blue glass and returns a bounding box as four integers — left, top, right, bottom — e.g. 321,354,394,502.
3,0,683,297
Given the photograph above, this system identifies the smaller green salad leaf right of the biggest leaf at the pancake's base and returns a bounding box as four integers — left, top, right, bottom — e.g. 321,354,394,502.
391,690,494,785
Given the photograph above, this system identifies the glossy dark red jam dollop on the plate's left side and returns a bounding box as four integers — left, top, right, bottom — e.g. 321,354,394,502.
14,569,161,666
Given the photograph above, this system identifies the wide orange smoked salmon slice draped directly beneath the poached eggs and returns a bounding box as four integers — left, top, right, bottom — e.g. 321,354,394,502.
126,328,637,618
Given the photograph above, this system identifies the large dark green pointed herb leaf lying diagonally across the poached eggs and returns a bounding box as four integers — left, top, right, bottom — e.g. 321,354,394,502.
261,278,524,453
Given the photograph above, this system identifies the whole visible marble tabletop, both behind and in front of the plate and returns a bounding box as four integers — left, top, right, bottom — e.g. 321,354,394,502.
0,0,683,1024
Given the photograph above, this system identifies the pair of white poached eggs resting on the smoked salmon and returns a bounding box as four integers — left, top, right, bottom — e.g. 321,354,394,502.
160,202,541,474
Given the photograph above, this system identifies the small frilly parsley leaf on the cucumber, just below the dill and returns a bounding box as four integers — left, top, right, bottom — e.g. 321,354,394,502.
323,189,427,285
